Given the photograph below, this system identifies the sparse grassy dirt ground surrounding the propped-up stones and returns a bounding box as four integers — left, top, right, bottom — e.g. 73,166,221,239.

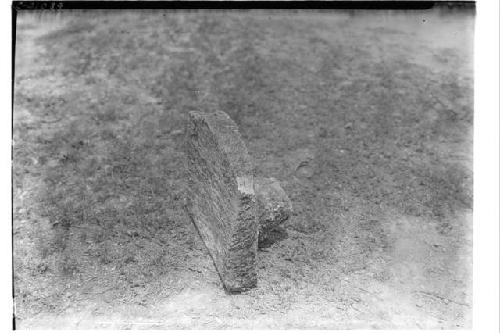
13,10,474,329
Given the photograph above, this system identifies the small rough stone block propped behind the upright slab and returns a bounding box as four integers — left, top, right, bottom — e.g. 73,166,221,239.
254,177,292,243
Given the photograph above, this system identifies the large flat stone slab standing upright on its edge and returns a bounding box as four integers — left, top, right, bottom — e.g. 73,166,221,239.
186,111,258,292
